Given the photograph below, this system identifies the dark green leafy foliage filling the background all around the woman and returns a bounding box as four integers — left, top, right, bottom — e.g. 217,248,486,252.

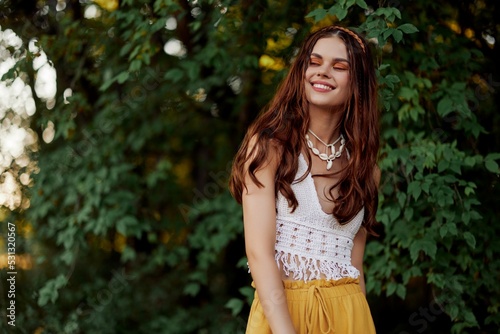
0,0,500,333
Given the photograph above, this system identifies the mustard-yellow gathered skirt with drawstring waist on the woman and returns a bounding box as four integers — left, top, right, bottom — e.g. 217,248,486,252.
246,278,375,334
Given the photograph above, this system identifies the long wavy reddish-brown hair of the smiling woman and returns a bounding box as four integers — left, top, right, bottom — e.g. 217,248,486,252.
229,26,379,233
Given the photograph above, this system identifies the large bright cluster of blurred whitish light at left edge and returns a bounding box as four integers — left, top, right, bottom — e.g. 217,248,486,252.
0,26,57,210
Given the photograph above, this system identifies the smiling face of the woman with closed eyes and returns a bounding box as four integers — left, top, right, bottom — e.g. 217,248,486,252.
304,36,350,111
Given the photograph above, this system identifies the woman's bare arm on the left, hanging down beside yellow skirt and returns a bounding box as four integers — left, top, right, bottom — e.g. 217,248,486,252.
242,145,295,334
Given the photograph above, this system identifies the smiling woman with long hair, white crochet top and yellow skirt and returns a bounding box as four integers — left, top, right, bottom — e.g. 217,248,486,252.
230,26,380,334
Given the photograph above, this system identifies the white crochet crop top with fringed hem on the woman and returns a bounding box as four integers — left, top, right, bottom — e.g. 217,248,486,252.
275,154,364,281
